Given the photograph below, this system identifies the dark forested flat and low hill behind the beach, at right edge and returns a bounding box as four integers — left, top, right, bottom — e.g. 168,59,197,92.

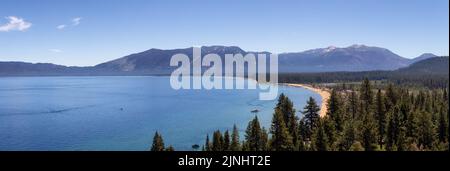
279,57,449,88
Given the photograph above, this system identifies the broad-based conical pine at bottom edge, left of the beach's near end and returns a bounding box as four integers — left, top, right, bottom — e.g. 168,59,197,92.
270,110,295,151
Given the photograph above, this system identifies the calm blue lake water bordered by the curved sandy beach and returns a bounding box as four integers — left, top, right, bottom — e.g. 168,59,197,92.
0,76,321,150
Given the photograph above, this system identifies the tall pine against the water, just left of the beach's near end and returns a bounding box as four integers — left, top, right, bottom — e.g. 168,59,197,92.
302,97,320,139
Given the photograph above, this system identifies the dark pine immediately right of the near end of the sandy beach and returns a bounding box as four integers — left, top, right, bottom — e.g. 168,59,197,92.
327,89,344,132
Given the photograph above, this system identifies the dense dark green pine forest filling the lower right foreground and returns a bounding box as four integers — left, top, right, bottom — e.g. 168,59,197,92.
152,79,449,151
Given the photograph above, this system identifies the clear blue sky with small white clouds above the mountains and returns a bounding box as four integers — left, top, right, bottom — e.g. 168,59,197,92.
0,0,449,66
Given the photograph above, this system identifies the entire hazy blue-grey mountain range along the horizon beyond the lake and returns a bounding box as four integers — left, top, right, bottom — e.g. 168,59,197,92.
0,45,442,76
